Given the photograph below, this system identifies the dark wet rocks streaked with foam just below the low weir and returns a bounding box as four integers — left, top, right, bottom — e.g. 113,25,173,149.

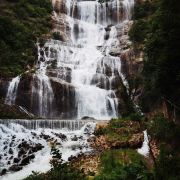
0,120,95,176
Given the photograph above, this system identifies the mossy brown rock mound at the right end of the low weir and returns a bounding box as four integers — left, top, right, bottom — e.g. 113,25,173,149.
94,117,143,149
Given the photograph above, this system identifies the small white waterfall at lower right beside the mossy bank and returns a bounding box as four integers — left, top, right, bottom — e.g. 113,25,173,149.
137,130,149,156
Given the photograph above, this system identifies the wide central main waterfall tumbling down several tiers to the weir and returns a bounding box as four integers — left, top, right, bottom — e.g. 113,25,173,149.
45,0,134,119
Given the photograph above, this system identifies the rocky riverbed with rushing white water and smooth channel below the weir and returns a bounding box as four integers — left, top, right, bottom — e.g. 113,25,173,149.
0,120,95,180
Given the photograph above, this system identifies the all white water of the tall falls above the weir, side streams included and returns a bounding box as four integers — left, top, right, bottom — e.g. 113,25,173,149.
5,0,134,119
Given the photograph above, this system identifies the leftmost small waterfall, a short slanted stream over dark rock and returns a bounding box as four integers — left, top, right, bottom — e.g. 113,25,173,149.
5,76,20,105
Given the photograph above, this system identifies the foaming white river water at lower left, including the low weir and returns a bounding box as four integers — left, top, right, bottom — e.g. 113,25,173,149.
0,120,95,180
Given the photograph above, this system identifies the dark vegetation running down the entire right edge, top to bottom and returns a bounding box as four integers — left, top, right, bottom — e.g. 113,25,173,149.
129,0,180,180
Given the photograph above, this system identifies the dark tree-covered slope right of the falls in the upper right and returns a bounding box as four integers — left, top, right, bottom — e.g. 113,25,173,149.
129,0,180,116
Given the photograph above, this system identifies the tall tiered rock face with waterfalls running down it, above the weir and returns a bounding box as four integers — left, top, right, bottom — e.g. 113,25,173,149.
3,0,134,119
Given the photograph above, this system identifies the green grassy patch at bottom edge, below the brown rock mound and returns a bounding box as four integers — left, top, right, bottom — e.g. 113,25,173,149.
94,150,152,180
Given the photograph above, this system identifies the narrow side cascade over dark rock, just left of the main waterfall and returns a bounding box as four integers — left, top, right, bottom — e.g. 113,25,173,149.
32,43,54,118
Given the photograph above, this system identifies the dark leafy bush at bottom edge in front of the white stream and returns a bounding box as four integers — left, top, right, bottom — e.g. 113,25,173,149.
25,148,85,180
